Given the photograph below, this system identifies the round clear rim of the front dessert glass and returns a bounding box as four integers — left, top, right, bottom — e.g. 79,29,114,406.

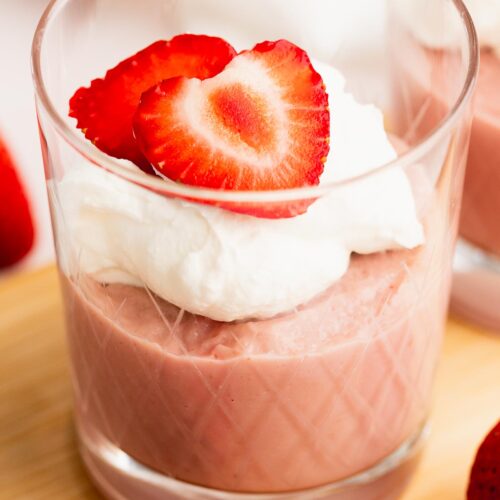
31,0,479,203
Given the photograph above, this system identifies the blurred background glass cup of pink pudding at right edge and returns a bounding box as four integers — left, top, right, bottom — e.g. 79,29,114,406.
451,10,500,332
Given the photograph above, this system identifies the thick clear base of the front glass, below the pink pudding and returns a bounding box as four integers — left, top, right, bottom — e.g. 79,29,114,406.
78,418,429,500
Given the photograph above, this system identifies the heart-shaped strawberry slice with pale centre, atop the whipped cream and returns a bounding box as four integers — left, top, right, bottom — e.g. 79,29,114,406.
134,40,330,218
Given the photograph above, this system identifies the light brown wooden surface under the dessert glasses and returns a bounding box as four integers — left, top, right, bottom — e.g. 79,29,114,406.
0,267,500,500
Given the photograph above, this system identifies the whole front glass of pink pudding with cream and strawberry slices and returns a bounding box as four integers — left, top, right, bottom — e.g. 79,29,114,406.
33,0,478,500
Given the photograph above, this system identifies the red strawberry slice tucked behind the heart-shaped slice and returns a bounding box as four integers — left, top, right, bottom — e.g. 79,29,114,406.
69,35,236,171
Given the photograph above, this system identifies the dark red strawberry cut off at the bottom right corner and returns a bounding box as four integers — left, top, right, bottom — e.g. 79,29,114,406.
467,421,500,500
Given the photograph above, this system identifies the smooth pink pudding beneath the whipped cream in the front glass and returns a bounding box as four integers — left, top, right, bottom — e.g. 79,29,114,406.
63,201,447,498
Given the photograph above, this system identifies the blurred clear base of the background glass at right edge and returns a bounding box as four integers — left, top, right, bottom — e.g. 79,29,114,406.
451,240,500,331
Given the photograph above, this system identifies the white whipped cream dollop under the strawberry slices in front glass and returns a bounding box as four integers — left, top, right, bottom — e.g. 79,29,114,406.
56,64,423,321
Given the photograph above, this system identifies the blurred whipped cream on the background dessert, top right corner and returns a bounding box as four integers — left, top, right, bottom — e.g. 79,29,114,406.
393,0,500,56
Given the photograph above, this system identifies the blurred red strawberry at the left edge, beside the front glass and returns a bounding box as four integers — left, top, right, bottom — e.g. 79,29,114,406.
0,140,34,269
